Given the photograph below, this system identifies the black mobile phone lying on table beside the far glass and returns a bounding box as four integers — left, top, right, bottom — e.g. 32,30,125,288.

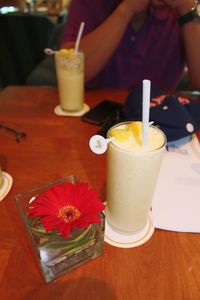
82,100,122,125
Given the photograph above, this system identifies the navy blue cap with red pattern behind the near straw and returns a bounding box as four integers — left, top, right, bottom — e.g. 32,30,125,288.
124,86,200,142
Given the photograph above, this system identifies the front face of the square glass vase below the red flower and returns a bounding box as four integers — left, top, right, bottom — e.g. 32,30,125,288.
37,219,104,282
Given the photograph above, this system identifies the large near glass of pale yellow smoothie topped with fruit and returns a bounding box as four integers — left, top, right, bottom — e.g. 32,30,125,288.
106,122,166,233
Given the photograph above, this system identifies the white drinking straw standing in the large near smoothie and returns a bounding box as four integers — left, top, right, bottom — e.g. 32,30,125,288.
142,79,151,147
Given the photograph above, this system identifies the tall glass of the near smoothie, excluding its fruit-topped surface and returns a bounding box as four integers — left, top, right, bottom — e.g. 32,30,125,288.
106,123,166,233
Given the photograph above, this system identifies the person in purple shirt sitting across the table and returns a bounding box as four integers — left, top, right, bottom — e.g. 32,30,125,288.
61,0,200,90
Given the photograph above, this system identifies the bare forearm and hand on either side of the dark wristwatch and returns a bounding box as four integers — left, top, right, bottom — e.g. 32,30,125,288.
164,0,200,89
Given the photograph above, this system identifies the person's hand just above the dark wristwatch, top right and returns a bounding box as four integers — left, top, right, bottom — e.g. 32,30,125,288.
159,0,195,15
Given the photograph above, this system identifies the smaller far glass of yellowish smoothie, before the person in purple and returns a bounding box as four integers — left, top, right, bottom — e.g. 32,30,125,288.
55,51,84,112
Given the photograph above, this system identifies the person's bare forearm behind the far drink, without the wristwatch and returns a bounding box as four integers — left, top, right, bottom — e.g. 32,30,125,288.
61,0,149,81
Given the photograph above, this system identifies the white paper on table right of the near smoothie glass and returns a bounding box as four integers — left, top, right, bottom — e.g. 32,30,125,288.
152,135,200,232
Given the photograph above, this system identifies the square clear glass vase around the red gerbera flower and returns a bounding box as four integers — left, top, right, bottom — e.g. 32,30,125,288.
15,175,105,282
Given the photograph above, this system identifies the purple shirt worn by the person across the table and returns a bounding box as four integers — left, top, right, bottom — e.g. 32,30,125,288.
62,0,184,90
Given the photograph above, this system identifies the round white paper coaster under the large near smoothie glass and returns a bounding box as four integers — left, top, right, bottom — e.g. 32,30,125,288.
104,214,154,248
